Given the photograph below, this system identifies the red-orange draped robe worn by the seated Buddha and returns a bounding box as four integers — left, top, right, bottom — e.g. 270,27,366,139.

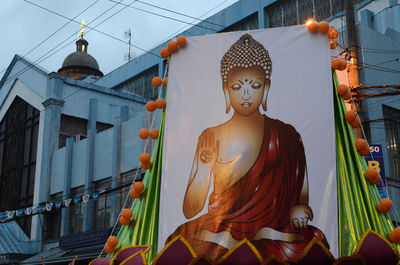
167,117,329,261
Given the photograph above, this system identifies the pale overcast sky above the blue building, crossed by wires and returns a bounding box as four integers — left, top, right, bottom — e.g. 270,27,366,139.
0,0,237,77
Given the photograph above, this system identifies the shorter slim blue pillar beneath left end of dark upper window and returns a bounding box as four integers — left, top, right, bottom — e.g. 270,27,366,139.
60,137,75,236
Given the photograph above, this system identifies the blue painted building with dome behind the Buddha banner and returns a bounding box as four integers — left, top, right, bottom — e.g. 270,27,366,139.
0,0,400,264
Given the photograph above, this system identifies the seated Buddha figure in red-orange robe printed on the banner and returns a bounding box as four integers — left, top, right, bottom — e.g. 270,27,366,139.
167,34,329,261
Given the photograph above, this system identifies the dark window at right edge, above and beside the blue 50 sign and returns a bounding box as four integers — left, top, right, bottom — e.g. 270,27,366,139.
382,105,400,178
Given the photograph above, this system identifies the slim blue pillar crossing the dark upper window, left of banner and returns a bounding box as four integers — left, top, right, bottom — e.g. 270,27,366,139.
82,98,97,231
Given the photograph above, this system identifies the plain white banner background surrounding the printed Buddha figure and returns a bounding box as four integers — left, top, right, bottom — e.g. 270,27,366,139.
158,26,338,257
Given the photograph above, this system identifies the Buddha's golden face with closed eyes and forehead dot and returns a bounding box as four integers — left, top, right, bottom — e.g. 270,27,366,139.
224,66,269,116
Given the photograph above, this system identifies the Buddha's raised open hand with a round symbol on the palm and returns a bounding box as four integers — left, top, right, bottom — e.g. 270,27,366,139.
199,130,219,165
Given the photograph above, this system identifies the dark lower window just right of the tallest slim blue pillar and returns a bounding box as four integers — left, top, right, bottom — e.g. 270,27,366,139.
94,178,111,228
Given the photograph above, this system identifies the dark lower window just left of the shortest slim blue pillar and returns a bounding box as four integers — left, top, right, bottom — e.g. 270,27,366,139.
43,192,63,240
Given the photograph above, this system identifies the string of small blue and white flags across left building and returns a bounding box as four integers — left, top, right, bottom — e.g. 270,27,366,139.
0,192,99,223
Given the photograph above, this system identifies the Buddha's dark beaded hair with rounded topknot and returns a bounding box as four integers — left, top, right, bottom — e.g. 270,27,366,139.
221,33,272,83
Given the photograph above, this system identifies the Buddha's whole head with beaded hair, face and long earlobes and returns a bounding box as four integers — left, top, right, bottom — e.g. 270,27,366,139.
221,34,272,116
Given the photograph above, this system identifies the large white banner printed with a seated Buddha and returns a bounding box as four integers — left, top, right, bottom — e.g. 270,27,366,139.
158,26,338,261
